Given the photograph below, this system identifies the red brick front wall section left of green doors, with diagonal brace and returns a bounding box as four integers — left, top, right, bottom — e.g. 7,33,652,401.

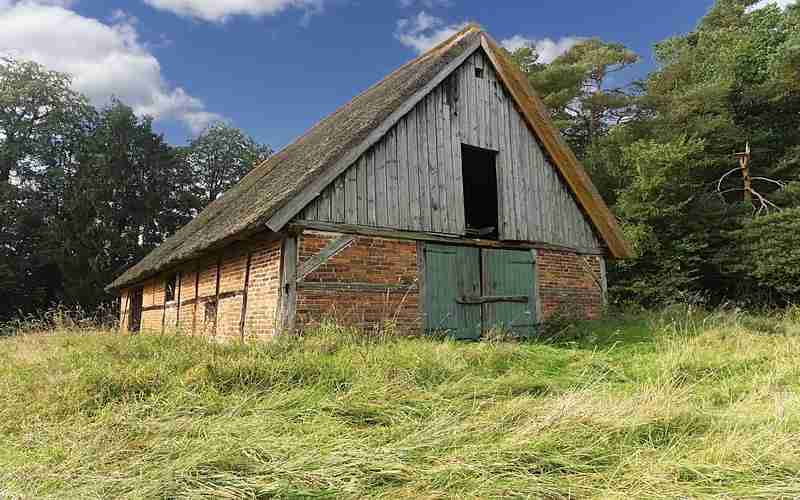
296,231,420,333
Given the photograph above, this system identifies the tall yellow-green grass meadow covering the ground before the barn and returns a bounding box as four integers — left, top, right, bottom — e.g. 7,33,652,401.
0,308,800,499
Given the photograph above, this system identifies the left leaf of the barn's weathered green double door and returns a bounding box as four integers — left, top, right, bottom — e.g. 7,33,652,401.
425,244,481,340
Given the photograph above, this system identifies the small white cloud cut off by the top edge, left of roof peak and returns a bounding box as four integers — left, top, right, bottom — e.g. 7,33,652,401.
144,0,323,22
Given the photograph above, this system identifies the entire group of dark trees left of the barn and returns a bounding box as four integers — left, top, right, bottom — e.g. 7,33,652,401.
0,59,270,320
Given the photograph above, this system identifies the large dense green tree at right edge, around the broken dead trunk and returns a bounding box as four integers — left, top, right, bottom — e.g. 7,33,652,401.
601,0,800,303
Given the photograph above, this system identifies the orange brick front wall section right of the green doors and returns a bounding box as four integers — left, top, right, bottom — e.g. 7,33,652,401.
537,250,603,319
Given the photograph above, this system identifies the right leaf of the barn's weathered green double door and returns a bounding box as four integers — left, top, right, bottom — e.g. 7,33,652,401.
481,249,537,337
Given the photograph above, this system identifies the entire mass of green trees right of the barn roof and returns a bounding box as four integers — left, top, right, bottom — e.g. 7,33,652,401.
514,0,800,305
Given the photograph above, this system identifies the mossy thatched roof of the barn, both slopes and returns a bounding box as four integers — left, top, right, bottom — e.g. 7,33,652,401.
108,24,627,290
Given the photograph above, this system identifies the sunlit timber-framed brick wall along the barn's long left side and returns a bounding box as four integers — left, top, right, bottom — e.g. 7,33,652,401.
120,236,282,338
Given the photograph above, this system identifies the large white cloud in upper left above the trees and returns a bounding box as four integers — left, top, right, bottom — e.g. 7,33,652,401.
0,0,220,132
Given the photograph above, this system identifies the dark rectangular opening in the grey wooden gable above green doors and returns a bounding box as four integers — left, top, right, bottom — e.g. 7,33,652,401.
461,144,498,239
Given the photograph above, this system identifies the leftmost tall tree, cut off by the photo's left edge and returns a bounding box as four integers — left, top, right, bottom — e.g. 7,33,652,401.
0,57,95,318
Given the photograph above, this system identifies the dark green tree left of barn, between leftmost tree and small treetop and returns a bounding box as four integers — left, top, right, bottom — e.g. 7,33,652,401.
48,100,192,309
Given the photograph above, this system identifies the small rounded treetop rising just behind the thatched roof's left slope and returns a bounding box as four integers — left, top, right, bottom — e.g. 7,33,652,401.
182,123,272,207
